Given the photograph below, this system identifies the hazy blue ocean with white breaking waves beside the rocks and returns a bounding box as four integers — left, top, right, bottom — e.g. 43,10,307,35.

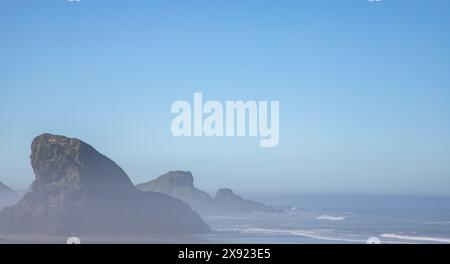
201,194,450,243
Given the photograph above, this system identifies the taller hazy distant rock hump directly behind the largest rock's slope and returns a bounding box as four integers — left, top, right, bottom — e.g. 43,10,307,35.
136,171,214,212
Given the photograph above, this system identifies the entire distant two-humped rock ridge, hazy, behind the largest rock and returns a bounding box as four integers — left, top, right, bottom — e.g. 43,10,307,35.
136,171,278,214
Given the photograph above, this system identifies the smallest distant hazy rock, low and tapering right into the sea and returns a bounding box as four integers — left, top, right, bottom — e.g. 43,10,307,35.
214,188,279,213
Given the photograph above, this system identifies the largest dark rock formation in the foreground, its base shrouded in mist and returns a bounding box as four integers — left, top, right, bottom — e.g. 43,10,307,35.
0,134,209,235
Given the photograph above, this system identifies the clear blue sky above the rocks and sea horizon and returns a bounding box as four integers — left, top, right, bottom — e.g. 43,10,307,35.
0,0,450,194
